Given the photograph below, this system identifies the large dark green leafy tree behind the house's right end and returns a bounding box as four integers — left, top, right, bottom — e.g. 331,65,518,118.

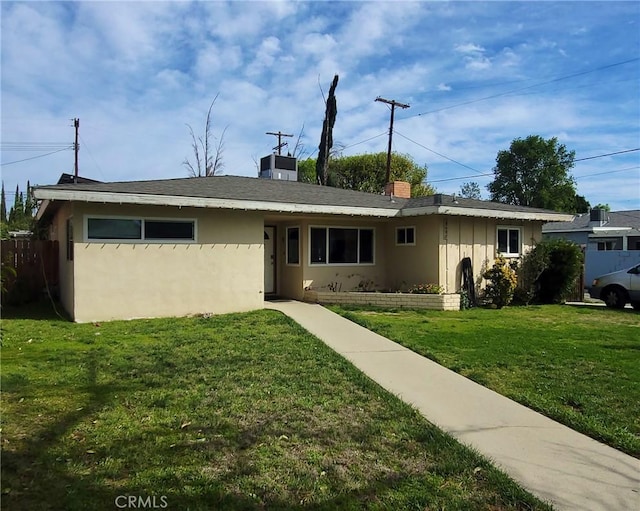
487,135,576,213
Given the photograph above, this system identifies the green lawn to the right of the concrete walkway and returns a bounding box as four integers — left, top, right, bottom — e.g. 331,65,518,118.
331,305,640,457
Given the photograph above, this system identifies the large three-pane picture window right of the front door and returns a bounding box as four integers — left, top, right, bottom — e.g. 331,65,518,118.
309,227,374,264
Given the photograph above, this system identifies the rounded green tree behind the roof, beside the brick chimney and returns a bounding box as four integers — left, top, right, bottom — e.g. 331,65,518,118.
328,152,435,197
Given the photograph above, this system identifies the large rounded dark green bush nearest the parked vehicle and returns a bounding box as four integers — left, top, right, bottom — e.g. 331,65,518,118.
518,239,584,303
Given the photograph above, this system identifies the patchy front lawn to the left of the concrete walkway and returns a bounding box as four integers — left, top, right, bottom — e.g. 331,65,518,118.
2,304,549,511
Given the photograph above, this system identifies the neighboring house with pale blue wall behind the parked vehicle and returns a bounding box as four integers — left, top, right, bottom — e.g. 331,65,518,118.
542,209,640,287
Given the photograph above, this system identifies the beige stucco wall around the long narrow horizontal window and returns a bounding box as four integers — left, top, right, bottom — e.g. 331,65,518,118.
67,204,264,322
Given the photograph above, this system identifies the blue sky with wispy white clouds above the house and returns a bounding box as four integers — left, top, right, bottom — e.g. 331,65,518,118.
1,1,640,210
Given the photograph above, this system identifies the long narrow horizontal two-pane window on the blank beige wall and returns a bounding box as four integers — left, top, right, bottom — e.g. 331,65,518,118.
86,217,196,241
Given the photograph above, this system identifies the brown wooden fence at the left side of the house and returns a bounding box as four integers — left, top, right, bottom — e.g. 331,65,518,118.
0,240,59,305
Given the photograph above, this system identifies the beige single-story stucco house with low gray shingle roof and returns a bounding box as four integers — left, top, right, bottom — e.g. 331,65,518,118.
34,169,572,322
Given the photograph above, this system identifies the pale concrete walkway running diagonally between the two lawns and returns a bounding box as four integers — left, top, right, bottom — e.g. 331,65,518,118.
265,301,640,511
